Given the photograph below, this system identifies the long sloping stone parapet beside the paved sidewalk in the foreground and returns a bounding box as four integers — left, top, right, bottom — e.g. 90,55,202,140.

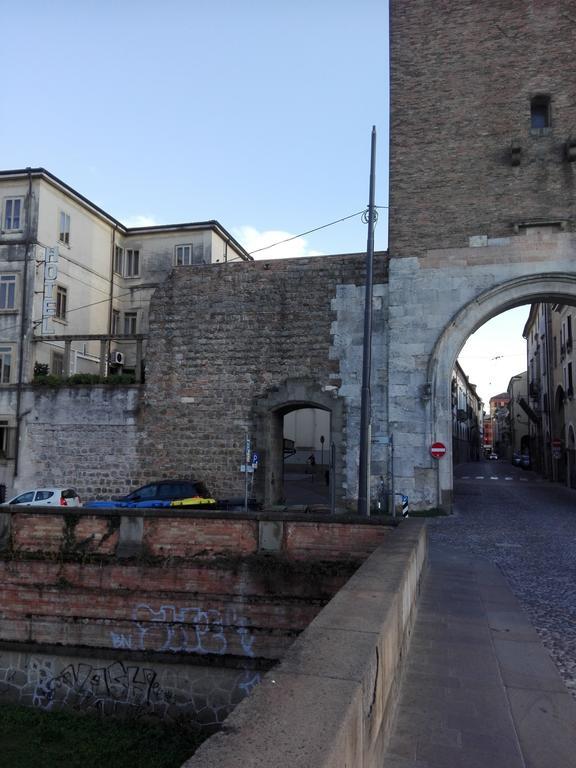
183,520,427,768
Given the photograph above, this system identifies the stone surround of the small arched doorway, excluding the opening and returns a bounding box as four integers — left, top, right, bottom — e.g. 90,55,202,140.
255,379,346,505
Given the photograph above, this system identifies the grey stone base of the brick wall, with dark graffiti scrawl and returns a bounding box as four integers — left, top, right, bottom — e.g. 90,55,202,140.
0,653,260,727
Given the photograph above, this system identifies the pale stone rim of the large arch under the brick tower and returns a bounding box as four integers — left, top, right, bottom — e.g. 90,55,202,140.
427,273,576,508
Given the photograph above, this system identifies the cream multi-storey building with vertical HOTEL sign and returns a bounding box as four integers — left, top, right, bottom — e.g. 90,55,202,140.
0,168,251,485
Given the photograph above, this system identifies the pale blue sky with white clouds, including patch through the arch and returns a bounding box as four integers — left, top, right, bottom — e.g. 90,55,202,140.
0,0,527,402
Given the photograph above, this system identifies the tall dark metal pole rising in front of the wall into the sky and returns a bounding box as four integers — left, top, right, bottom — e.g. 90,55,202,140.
358,126,376,517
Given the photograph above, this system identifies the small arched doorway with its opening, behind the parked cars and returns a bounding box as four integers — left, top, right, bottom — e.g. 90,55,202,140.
256,379,344,506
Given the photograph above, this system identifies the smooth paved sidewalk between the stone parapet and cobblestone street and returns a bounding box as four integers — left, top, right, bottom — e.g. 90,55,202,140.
384,543,576,768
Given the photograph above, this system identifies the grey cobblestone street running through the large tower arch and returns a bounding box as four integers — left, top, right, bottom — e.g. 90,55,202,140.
429,461,576,697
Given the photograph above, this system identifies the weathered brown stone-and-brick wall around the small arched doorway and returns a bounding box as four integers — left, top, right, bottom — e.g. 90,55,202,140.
140,254,386,504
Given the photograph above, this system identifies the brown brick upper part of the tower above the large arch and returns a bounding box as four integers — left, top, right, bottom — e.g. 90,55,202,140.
390,0,576,256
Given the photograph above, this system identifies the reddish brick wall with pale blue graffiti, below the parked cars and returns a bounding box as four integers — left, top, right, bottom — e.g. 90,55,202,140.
0,508,393,659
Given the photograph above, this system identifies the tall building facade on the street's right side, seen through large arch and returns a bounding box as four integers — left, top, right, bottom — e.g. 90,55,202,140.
523,303,576,488
